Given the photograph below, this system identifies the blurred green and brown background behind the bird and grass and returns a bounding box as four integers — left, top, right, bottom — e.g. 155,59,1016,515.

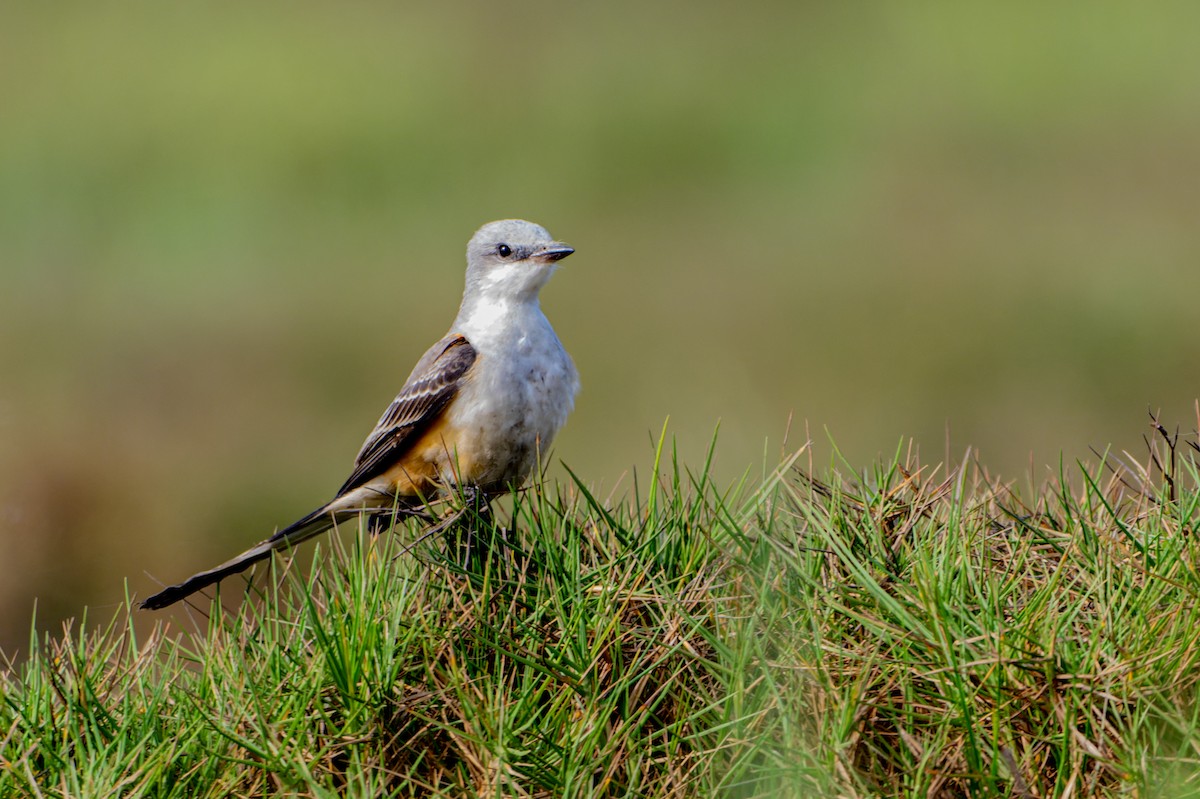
0,0,1200,651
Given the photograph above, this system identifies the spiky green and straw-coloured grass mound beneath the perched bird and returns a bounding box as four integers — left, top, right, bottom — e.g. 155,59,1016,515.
0,431,1200,797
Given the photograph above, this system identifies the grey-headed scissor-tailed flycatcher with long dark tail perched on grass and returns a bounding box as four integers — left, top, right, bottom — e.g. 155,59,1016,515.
142,220,580,609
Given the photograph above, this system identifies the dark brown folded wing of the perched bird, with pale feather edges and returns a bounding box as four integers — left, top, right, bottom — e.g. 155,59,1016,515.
337,334,475,497
